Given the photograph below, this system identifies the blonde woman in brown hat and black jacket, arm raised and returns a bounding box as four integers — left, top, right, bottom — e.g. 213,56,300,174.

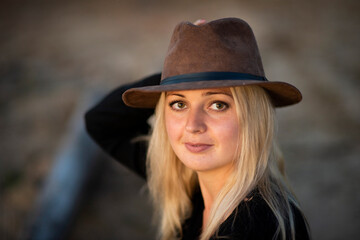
86,18,309,240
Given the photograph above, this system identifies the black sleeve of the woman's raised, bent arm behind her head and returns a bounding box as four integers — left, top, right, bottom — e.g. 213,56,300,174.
85,74,161,178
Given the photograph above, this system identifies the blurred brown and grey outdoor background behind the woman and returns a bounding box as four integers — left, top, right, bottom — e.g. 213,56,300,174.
0,0,360,240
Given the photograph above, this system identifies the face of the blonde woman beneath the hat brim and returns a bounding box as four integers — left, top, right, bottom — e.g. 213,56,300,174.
165,88,239,172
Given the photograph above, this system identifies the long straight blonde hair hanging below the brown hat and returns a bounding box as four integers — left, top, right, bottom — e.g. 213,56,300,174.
147,86,306,240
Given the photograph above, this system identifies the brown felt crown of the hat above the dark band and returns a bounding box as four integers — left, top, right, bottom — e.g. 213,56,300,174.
162,18,265,79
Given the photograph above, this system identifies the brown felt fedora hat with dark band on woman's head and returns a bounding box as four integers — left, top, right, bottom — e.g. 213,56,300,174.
123,18,302,108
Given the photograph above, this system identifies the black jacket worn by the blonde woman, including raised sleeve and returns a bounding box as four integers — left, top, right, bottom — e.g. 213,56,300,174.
85,74,309,240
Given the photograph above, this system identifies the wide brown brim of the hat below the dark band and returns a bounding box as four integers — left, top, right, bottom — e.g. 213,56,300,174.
122,80,302,108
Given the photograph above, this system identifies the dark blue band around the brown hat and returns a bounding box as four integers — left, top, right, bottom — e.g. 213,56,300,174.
160,72,268,85
